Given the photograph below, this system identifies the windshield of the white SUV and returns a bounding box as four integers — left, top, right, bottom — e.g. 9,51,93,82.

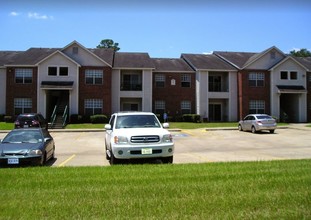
116,115,161,129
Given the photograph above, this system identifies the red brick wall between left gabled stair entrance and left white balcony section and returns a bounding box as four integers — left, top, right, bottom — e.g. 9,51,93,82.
79,66,112,115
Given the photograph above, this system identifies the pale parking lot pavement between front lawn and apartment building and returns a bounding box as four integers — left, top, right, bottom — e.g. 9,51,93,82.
0,125,311,167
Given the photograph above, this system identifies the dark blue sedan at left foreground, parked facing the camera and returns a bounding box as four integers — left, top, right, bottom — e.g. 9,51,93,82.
0,128,55,166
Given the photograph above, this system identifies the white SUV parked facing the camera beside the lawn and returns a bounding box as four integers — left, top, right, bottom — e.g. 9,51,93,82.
105,112,174,165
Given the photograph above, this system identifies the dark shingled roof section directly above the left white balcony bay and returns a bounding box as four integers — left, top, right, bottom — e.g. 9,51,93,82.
113,52,154,69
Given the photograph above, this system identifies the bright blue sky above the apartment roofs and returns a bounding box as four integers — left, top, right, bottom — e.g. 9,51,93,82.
0,0,311,58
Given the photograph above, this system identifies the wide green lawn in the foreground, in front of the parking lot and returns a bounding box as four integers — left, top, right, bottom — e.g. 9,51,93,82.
0,160,311,219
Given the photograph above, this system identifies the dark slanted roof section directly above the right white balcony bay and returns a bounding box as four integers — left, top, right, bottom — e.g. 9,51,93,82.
181,54,236,71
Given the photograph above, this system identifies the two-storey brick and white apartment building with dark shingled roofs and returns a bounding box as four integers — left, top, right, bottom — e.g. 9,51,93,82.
0,41,311,122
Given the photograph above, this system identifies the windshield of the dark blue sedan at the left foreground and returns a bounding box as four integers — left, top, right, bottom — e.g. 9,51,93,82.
2,130,43,143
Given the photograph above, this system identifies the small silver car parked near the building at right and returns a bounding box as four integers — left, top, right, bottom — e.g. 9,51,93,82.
238,114,277,133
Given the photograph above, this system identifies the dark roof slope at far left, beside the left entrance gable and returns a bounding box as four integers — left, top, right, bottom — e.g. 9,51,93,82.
5,48,58,66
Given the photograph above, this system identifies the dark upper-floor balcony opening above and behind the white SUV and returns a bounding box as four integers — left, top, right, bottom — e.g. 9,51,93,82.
121,71,142,91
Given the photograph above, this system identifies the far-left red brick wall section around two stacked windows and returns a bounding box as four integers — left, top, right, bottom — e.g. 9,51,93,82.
6,67,38,116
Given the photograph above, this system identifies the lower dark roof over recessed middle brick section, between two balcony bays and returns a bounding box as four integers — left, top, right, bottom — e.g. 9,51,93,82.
151,58,194,72
